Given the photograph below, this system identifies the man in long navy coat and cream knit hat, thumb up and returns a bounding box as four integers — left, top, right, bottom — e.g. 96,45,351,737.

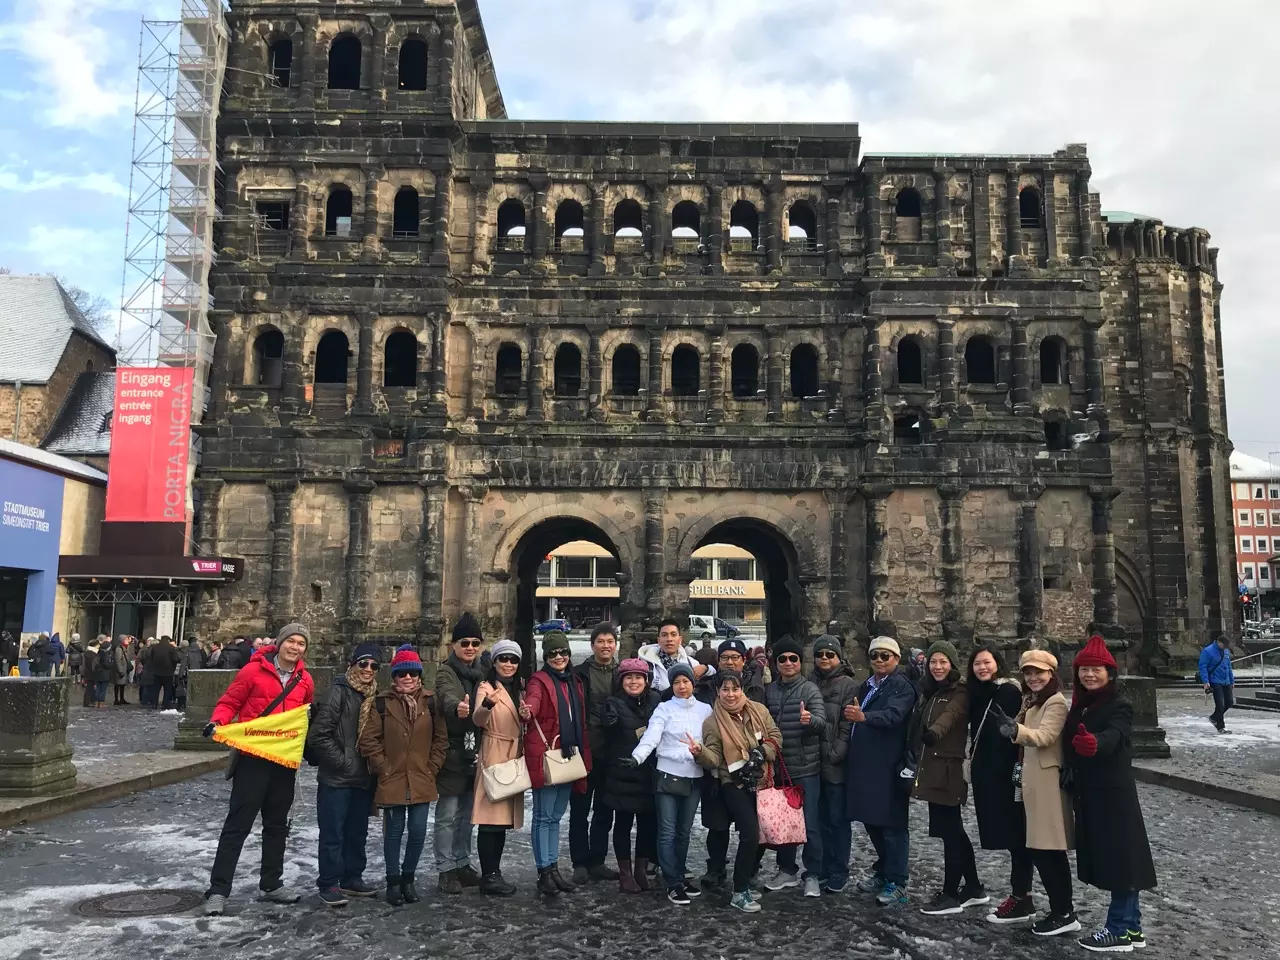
845,636,915,906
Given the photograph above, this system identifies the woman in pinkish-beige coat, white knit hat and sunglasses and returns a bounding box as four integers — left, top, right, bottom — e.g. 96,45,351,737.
471,640,525,897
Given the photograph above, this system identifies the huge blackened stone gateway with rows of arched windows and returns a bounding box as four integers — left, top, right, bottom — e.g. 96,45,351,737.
197,0,1235,669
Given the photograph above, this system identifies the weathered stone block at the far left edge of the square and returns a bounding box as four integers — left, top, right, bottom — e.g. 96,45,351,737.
0,677,76,796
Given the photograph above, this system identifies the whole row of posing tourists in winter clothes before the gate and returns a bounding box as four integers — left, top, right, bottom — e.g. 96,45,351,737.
205,614,1156,952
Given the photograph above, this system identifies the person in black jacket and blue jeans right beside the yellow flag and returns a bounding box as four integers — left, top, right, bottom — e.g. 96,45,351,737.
307,644,380,908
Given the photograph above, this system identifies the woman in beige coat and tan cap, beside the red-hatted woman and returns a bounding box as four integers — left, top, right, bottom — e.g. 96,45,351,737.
987,650,1080,937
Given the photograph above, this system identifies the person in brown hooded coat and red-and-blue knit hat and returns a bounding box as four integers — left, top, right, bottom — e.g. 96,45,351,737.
356,644,448,906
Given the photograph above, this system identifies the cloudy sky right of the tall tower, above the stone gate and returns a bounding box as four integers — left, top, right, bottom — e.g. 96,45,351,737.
481,0,1280,456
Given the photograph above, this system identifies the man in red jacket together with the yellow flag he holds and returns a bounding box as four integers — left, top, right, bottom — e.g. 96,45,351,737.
205,623,315,916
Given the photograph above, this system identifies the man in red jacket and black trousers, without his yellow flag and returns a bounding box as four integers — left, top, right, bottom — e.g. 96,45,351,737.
205,623,315,916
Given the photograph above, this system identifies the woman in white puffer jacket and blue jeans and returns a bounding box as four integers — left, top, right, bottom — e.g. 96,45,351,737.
631,663,712,905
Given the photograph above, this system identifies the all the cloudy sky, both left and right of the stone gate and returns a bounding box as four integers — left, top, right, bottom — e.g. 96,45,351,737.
0,0,1280,460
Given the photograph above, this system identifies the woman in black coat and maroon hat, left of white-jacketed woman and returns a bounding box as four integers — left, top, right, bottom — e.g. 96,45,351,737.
591,657,660,893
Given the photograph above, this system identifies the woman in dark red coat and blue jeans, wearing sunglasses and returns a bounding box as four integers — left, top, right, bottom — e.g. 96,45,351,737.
520,630,591,896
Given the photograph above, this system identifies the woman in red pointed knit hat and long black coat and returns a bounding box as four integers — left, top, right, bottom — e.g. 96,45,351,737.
1062,636,1156,954
